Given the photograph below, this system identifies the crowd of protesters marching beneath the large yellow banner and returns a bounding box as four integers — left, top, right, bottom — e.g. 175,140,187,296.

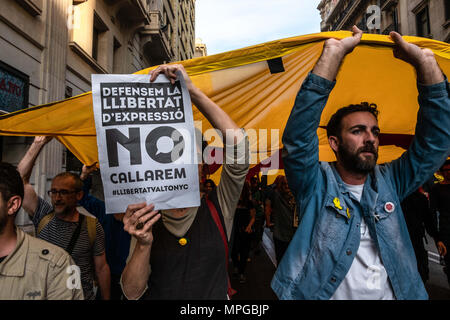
0,27,450,300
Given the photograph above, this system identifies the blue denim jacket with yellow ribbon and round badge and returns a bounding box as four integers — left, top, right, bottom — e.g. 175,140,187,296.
271,73,450,299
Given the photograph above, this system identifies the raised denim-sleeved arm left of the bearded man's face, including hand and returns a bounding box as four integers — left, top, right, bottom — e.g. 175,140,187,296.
283,27,362,199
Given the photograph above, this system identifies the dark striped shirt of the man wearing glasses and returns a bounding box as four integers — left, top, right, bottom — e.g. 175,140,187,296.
33,197,105,300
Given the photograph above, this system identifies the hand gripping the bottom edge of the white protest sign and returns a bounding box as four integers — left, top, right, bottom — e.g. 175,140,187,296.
123,202,161,246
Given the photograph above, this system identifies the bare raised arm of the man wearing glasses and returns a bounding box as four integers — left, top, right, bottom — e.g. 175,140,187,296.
17,136,52,217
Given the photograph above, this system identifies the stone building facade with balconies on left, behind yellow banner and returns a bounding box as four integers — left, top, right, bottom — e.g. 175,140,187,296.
0,0,195,226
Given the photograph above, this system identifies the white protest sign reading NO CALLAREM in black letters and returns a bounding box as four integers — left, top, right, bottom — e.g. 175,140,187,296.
92,73,200,213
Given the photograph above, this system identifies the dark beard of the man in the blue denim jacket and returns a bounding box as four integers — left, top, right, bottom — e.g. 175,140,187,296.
338,143,378,174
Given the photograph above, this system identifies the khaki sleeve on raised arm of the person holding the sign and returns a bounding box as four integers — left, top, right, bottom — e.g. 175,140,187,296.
217,130,249,239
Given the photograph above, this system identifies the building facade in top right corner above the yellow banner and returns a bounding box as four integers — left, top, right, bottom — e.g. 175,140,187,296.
317,0,450,43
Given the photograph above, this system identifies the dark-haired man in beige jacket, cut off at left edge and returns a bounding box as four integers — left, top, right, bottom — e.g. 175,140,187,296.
0,162,84,300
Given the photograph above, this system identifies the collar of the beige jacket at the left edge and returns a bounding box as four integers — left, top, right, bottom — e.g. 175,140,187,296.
0,227,28,277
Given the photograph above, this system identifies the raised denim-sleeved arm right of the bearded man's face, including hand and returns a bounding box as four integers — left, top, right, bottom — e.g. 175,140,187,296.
387,32,450,201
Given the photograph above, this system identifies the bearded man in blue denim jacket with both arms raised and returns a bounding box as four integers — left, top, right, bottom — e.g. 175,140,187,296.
271,26,450,300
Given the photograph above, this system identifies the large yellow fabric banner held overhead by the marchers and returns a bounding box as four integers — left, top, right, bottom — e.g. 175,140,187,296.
0,31,450,169
